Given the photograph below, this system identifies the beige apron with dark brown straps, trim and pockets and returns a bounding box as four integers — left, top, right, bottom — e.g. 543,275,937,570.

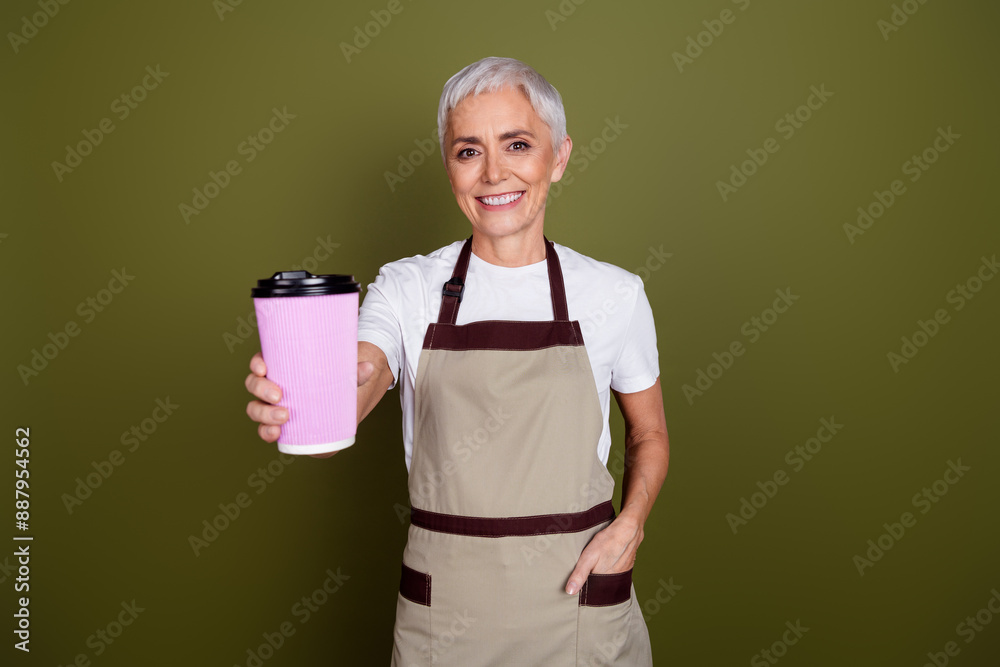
392,239,652,667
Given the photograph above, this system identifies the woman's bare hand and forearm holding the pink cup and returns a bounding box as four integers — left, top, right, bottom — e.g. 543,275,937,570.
245,342,392,459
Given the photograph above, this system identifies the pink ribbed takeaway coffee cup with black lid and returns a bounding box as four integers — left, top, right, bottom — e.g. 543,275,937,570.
251,271,360,454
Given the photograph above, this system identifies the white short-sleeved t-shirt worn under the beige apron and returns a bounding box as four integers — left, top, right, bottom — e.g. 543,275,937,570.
358,240,660,470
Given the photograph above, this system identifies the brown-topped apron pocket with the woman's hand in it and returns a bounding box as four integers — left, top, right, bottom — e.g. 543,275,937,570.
576,570,647,667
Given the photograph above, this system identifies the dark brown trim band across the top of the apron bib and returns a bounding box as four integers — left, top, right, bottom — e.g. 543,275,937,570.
424,320,583,351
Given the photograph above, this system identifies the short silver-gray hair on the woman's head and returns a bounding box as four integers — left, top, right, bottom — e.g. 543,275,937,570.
438,56,566,160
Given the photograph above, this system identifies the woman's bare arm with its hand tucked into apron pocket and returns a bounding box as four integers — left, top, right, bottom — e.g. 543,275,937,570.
566,378,670,595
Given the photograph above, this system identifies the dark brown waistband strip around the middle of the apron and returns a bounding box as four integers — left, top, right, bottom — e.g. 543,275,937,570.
410,500,615,537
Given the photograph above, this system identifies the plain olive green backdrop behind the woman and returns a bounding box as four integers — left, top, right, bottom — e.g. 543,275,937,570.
0,0,1000,667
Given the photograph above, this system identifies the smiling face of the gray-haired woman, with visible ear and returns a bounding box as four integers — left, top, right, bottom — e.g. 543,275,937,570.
445,88,573,245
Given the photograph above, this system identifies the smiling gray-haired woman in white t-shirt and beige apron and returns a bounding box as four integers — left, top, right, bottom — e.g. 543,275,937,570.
246,58,668,667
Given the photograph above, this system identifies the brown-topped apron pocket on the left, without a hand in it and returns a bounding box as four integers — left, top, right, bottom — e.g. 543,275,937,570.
392,563,431,667
